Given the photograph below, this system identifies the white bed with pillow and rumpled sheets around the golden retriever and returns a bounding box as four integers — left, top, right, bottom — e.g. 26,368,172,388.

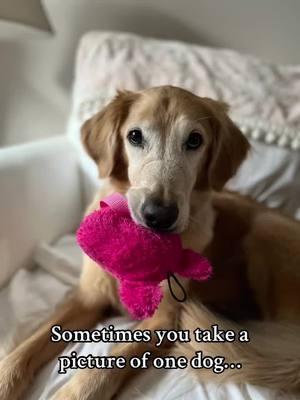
0,32,300,400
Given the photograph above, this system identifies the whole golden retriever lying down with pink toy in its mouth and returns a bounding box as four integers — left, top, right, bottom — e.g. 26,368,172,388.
0,86,300,400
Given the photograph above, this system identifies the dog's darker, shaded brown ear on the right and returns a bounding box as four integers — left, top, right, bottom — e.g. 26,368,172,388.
202,98,250,190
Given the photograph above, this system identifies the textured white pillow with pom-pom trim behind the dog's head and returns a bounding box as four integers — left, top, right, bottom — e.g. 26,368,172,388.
69,32,300,218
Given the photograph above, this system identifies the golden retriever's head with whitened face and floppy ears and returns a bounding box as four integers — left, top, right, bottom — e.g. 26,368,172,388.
82,86,249,232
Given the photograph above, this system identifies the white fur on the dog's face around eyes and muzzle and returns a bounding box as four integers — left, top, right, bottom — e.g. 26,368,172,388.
124,115,209,233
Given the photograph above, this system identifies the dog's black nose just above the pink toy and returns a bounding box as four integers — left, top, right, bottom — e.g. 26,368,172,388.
142,200,178,231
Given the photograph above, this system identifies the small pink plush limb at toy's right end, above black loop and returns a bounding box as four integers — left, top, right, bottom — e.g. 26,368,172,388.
176,249,212,281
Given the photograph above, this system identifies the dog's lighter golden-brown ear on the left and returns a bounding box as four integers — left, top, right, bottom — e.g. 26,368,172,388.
81,91,137,180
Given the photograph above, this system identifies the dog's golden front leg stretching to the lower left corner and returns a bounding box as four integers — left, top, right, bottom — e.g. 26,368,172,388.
0,260,117,400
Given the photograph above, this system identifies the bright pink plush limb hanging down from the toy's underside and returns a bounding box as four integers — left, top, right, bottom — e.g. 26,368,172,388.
119,281,163,319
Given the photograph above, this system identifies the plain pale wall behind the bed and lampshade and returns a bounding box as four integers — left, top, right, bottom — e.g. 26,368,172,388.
0,0,300,145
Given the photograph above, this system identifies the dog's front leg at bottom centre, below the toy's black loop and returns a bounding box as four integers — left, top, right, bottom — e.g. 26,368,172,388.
51,295,180,400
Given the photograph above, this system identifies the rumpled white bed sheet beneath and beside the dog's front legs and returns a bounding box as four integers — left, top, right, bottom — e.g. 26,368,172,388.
0,236,296,400
